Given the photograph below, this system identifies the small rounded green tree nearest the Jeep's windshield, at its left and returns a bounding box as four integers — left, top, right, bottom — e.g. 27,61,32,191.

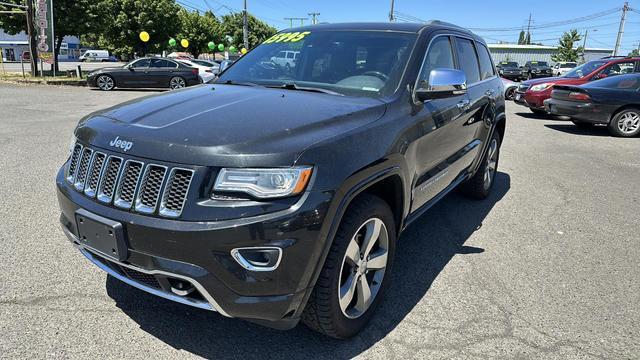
177,9,224,58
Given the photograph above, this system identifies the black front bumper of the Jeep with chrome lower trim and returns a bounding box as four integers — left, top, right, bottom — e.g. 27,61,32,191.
57,167,333,329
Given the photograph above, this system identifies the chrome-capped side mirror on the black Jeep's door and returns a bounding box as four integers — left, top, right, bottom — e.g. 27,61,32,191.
416,69,467,101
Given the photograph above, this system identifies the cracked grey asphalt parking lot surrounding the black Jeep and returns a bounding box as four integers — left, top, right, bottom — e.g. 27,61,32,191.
0,84,640,359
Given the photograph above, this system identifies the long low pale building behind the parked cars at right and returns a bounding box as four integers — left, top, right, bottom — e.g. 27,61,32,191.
487,44,613,65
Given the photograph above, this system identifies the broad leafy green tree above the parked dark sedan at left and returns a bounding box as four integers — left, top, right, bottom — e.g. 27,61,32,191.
97,0,181,58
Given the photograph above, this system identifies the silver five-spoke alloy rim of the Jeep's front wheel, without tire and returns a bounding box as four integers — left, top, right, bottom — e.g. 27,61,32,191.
338,218,389,319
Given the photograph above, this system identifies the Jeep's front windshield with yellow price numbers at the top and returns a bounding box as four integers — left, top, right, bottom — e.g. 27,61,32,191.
217,31,417,97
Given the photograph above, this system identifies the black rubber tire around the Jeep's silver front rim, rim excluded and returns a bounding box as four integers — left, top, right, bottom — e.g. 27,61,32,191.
302,194,396,339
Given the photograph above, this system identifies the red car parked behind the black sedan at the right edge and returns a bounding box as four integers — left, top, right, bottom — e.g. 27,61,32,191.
514,57,640,115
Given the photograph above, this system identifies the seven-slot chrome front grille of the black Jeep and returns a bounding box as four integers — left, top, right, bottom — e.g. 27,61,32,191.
65,144,194,218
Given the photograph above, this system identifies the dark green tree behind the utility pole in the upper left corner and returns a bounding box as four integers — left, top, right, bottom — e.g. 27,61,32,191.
0,0,98,71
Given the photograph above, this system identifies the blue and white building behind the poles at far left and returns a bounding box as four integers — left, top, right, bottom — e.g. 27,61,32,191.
0,29,80,61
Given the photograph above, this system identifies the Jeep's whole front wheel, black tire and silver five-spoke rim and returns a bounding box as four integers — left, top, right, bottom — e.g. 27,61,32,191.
302,194,396,339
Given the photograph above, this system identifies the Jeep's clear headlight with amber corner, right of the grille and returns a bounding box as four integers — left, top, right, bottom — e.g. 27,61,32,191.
213,166,313,199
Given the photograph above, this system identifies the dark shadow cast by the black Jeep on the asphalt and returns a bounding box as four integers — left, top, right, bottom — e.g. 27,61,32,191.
106,172,511,359
